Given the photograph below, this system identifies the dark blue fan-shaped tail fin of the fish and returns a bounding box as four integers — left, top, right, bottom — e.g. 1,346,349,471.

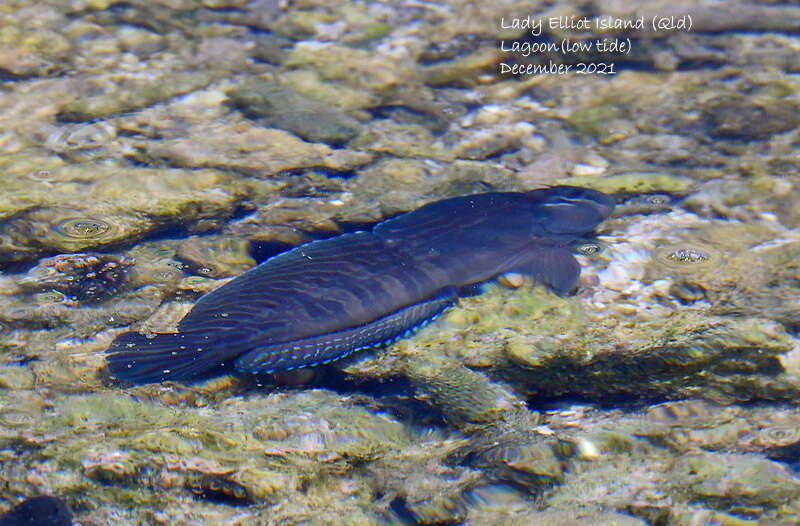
106,332,245,384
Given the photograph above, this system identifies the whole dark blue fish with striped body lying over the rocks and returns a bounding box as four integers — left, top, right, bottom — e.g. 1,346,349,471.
108,186,614,383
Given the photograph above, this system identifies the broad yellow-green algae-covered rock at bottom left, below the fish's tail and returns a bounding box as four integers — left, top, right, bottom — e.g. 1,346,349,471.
0,390,475,522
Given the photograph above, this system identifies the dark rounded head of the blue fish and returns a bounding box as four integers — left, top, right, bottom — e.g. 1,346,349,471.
526,186,616,235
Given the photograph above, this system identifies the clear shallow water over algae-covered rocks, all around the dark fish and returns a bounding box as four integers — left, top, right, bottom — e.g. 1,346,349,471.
0,0,800,525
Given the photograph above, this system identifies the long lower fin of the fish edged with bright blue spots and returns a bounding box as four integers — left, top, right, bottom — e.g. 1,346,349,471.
235,287,456,374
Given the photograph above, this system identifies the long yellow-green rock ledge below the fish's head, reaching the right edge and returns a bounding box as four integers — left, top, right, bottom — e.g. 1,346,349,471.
344,262,797,406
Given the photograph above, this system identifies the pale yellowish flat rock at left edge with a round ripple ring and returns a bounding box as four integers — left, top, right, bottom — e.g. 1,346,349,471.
0,163,243,263
